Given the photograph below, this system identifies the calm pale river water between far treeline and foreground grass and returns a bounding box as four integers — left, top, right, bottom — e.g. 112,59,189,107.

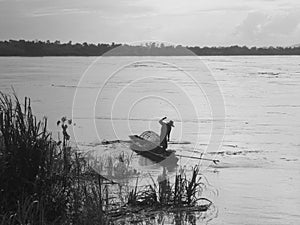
0,56,300,224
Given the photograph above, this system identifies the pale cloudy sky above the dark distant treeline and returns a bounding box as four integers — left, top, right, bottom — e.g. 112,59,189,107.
0,0,300,46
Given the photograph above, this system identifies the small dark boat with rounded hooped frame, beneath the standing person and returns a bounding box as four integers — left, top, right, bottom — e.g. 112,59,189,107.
129,131,178,164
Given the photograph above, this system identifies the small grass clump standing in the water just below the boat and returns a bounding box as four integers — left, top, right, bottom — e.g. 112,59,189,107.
128,166,212,210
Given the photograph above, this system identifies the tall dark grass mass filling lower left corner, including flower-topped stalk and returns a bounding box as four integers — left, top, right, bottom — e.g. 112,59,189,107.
0,93,107,224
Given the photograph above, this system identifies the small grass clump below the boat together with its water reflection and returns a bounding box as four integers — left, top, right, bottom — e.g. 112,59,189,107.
108,166,214,224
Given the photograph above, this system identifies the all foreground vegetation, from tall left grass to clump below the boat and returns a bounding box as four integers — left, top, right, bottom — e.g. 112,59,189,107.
0,92,216,225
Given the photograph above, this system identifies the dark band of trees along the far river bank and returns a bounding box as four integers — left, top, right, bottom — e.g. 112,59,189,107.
0,40,300,56
